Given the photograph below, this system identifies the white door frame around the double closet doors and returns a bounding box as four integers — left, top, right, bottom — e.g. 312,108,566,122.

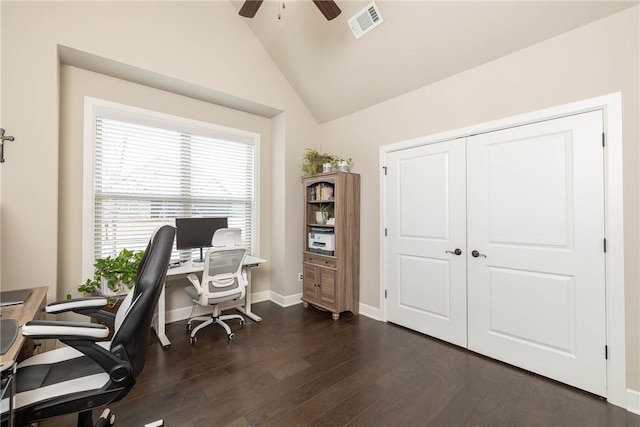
379,92,626,408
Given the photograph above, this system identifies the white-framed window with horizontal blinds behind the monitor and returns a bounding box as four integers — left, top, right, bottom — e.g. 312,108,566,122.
83,98,259,275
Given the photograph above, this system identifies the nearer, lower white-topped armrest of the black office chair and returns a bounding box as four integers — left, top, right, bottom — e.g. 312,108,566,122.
22,320,109,341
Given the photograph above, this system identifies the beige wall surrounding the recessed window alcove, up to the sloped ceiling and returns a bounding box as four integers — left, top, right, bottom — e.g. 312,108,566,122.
0,1,318,310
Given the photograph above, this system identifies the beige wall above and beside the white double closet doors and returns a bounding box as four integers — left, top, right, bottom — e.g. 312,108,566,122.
320,7,640,390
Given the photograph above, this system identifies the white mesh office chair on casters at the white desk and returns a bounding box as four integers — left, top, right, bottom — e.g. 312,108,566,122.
184,228,247,344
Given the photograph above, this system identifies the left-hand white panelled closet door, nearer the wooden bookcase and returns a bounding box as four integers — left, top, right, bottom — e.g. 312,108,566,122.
385,139,467,346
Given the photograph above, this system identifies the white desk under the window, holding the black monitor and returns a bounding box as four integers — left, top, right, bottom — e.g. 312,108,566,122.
151,255,267,348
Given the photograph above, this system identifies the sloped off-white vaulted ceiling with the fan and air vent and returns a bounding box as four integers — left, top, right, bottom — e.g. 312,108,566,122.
231,0,638,123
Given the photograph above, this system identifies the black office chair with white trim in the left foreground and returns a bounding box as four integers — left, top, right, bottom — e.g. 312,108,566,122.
2,226,175,427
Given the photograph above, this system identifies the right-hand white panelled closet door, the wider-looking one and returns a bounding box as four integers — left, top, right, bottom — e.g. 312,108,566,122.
467,112,606,396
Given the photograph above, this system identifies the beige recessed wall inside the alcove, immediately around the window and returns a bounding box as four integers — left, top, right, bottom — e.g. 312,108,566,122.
58,65,271,310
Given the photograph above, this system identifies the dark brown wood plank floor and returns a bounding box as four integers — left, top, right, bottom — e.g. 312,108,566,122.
40,302,640,427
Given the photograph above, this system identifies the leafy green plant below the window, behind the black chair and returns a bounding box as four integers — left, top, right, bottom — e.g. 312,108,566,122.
73,249,144,303
